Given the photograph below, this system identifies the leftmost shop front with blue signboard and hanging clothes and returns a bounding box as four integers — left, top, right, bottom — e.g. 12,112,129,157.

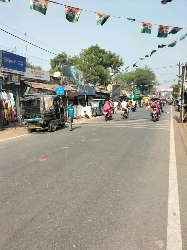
0,50,26,124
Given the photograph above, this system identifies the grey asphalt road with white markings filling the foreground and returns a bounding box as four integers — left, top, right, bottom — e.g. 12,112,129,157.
0,105,187,250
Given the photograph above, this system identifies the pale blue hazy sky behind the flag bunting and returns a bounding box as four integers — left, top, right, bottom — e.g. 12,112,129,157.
0,0,187,88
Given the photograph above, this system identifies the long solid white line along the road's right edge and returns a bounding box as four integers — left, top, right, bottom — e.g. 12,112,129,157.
167,107,182,250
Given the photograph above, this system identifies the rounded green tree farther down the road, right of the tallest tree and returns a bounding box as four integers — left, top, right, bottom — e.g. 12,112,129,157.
115,66,159,93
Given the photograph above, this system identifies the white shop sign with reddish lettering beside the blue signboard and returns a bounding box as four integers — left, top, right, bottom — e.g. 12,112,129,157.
24,68,50,82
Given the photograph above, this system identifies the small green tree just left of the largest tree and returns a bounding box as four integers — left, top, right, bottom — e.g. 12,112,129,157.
49,52,68,74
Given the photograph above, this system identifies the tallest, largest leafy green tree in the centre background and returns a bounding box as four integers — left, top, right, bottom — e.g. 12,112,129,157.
68,44,123,85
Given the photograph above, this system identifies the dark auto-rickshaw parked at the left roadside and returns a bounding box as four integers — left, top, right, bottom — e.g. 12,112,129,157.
21,94,65,133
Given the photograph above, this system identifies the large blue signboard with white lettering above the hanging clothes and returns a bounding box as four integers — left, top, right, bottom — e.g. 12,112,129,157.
0,50,26,75
